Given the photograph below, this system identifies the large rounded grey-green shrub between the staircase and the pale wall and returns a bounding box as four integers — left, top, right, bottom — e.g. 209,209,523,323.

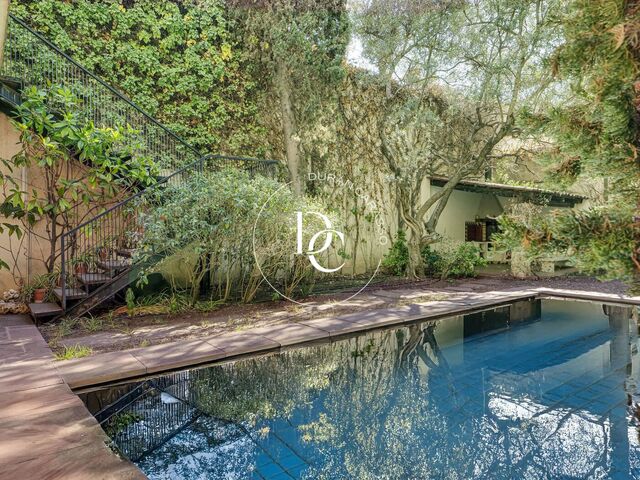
141,170,336,305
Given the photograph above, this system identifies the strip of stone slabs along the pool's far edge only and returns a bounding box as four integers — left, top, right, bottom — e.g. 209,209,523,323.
57,288,640,389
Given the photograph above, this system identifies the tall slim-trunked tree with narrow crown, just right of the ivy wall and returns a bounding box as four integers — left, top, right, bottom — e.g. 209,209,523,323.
235,0,348,195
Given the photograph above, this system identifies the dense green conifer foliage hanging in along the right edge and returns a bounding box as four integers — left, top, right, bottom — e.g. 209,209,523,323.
503,0,640,284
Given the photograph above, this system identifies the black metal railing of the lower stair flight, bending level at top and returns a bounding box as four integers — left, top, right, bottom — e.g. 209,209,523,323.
59,155,278,310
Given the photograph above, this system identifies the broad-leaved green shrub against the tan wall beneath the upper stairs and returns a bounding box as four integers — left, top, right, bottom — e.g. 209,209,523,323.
0,84,157,278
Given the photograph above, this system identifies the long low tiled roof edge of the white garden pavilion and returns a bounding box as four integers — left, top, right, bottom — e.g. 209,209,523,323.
431,177,588,207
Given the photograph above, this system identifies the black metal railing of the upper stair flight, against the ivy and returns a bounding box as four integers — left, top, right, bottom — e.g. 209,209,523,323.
0,14,200,173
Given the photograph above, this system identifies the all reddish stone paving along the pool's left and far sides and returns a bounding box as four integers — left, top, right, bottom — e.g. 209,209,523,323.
0,287,640,480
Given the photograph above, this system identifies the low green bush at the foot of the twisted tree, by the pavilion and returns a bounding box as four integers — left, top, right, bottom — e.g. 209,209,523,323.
422,242,486,280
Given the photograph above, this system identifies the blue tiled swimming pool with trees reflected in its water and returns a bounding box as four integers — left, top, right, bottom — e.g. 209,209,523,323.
85,300,640,480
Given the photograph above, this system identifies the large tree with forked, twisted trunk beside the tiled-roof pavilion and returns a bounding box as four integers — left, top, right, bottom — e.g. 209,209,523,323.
354,0,558,277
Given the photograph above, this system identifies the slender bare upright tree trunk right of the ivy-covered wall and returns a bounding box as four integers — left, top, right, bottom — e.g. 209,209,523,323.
276,60,304,196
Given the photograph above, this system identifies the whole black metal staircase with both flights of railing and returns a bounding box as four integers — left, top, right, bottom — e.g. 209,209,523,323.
0,14,277,321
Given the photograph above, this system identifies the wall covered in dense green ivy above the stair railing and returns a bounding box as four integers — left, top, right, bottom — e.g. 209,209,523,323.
11,0,266,156
